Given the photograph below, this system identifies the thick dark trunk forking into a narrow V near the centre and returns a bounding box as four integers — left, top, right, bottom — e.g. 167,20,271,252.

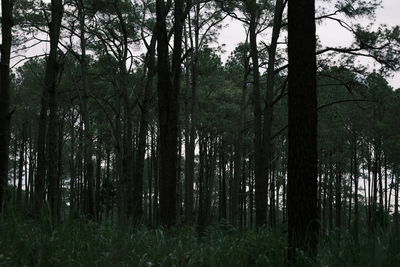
156,0,184,226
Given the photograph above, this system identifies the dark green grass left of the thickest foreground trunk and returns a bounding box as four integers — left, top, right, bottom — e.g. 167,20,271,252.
0,218,285,266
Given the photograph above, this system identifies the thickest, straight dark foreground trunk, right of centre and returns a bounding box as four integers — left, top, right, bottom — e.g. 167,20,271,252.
288,0,319,263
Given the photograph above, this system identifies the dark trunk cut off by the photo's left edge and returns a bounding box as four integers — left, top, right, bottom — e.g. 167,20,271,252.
0,0,13,212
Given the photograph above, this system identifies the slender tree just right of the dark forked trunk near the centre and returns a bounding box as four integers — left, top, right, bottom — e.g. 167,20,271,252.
184,1,224,224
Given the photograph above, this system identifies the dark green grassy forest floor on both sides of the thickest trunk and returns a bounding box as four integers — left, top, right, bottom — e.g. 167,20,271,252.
0,215,400,267
